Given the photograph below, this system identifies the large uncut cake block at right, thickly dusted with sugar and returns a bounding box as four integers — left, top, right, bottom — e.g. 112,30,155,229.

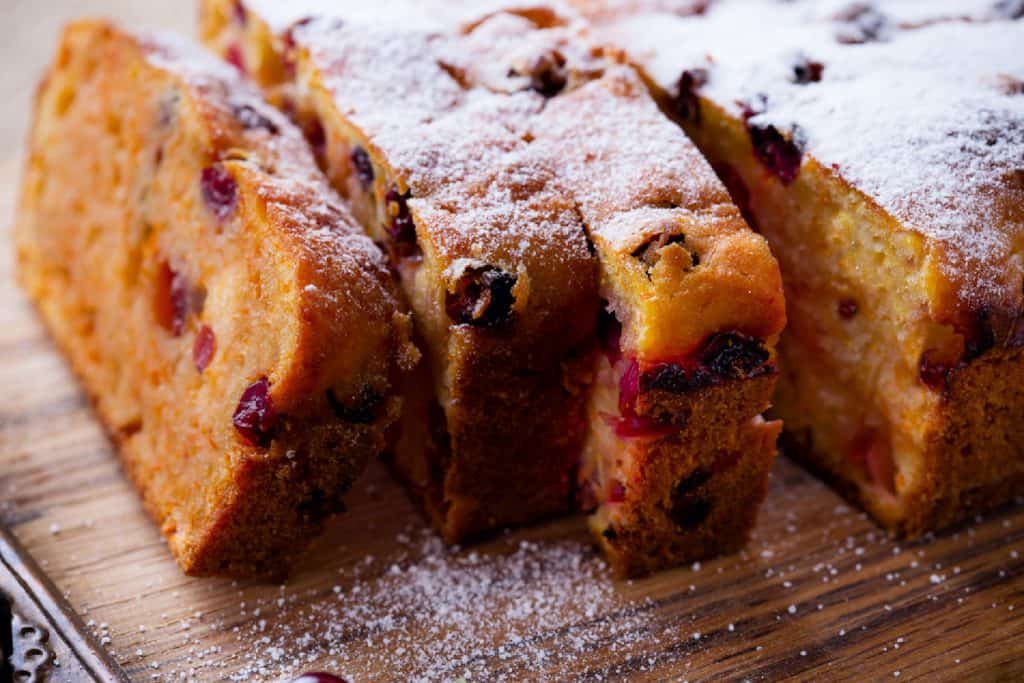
579,0,1024,535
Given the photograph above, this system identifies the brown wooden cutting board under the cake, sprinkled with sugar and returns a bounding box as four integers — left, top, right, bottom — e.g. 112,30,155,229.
0,154,1024,681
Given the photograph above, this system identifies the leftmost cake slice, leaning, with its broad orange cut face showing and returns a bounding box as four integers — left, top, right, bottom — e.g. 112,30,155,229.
14,22,417,577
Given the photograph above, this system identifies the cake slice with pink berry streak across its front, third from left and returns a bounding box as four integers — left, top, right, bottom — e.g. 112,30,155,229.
449,9,785,577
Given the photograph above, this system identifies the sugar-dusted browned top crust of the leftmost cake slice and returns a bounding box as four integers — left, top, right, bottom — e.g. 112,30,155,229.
117,23,418,403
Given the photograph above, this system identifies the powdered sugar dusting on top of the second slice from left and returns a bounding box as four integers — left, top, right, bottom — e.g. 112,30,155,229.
295,13,589,264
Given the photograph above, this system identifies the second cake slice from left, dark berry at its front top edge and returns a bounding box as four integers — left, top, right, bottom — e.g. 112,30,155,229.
202,0,598,543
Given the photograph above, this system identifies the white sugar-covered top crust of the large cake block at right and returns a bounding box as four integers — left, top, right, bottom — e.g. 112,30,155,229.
575,0,1024,331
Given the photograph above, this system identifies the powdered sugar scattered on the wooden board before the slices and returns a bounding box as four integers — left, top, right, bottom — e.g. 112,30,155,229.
221,530,655,681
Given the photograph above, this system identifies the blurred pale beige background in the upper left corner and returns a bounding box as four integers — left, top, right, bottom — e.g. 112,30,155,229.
0,0,197,158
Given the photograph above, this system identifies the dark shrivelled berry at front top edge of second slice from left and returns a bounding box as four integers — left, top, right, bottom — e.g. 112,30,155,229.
444,265,518,328
